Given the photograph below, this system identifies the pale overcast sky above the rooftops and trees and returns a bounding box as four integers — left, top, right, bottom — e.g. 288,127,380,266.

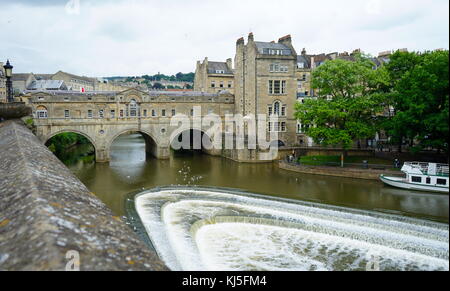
0,0,449,77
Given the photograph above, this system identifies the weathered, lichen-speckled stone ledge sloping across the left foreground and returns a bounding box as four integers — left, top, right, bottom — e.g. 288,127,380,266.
0,120,167,271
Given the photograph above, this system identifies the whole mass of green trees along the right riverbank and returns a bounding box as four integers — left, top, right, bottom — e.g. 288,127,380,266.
295,51,449,157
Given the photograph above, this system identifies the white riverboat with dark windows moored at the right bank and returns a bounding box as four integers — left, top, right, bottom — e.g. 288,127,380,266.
380,162,449,194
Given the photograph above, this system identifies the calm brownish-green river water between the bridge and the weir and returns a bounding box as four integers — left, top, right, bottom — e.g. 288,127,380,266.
67,134,449,222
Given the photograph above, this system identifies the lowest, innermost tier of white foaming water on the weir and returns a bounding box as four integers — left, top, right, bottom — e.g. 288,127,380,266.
196,223,449,271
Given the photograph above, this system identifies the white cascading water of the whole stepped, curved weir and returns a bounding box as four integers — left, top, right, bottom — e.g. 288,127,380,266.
135,188,449,271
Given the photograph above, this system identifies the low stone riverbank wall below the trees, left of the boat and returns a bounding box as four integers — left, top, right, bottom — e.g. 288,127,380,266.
278,161,402,181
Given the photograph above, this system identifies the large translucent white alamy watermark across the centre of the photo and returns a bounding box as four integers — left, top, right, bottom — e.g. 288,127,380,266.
170,106,286,159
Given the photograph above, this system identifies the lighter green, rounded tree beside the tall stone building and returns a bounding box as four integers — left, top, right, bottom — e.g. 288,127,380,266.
295,55,387,154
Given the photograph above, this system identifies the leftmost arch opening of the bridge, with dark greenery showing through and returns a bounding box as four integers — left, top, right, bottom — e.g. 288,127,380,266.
45,131,96,165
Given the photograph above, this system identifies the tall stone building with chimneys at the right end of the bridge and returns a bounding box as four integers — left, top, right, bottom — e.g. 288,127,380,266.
234,33,297,146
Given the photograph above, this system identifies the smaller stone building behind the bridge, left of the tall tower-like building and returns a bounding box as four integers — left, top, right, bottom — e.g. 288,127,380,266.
194,58,234,94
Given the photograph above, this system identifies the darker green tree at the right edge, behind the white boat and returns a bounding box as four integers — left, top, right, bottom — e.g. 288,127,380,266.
384,51,449,152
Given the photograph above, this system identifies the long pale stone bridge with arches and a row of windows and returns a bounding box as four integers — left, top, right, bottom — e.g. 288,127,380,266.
22,89,234,162
